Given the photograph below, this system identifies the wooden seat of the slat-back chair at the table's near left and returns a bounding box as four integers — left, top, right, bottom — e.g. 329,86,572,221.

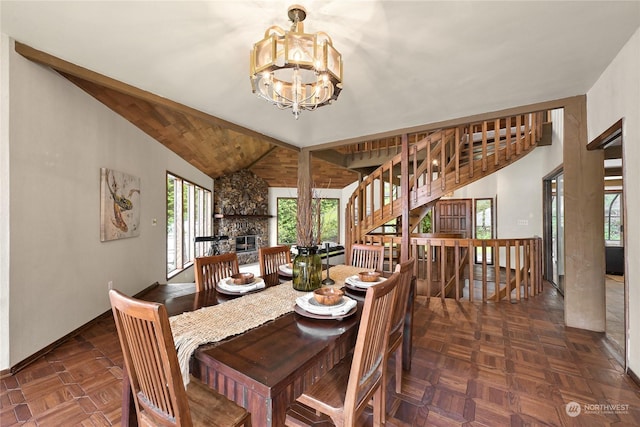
187,378,249,427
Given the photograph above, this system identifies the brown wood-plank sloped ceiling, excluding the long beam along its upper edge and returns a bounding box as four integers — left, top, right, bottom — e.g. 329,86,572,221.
61,73,358,188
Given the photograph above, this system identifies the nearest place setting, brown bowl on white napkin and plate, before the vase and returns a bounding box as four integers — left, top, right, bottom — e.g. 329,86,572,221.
294,287,357,320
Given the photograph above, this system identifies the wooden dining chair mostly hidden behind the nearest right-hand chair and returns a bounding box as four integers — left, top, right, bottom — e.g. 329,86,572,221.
387,258,415,394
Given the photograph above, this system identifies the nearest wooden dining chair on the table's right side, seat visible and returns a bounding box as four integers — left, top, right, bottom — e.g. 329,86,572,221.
285,273,400,427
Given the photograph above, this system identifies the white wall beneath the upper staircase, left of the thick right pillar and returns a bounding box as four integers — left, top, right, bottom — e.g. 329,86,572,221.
453,110,564,239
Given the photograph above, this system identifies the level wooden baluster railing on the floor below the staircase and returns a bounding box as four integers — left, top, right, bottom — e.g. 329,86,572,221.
352,234,543,302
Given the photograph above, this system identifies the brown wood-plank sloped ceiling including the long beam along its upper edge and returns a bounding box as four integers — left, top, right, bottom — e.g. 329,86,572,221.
16,42,358,188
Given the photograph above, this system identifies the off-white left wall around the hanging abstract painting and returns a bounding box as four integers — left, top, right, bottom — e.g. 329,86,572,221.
0,43,213,369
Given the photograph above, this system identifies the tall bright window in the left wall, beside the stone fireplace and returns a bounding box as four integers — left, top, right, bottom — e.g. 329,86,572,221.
167,173,211,277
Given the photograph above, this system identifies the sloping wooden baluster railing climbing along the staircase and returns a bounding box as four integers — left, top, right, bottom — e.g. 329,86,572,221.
345,112,546,250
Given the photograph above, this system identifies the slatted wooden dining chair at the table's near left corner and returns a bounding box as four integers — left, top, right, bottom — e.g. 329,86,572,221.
109,289,251,426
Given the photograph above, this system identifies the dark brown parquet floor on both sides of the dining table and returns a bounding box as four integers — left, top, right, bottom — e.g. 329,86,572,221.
0,287,640,426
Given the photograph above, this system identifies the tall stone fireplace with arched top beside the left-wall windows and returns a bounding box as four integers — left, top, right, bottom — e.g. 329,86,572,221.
213,170,269,264
